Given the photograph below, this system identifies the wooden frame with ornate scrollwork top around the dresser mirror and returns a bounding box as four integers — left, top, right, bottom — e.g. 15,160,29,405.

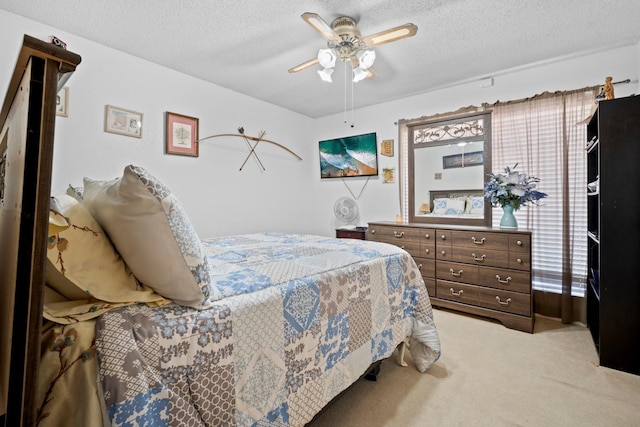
407,111,492,227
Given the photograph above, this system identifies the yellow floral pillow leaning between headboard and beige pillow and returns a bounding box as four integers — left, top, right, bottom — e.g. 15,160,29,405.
44,195,165,323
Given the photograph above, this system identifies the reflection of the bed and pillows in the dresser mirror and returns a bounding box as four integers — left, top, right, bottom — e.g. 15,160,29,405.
416,189,485,219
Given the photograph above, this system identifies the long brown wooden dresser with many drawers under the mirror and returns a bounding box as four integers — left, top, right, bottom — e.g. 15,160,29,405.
368,222,534,333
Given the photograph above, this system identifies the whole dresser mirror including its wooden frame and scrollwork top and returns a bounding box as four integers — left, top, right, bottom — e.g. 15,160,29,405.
407,112,491,226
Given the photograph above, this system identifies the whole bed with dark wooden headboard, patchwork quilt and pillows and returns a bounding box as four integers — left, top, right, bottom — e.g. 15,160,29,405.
0,37,440,426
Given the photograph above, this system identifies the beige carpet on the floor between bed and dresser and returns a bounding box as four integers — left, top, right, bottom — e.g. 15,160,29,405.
309,309,640,427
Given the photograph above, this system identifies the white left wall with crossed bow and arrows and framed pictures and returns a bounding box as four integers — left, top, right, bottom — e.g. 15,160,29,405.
0,10,317,237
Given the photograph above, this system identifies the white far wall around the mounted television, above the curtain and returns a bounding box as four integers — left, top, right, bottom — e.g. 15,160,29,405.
313,44,640,236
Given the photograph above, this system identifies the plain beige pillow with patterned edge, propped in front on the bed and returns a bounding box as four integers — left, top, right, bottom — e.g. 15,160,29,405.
84,165,220,309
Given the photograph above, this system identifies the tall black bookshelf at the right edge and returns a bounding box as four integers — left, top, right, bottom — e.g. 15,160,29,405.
587,96,640,375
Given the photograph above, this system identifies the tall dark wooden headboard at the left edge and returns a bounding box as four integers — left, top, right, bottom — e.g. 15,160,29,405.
0,35,80,426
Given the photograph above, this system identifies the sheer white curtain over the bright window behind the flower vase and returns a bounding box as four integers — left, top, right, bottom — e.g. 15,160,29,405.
489,88,596,322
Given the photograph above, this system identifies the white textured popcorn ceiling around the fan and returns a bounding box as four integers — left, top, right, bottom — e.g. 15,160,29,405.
0,0,640,117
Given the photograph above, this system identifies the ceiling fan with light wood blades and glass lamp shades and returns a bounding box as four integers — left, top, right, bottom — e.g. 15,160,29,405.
289,12,418,82
